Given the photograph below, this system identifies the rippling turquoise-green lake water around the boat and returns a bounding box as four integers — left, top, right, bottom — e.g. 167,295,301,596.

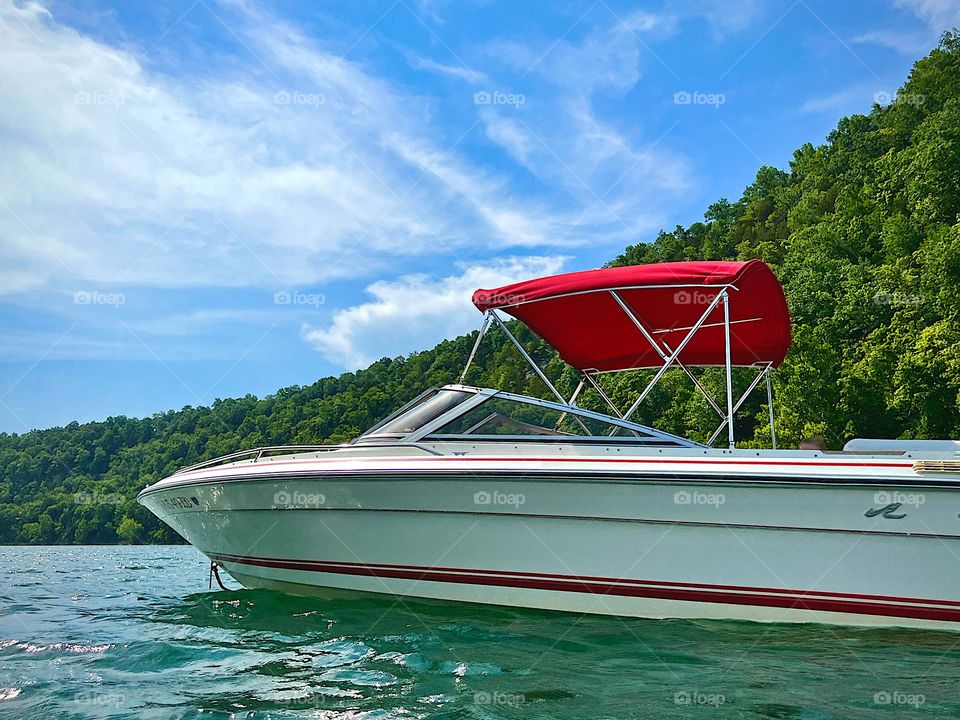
0,547,960,720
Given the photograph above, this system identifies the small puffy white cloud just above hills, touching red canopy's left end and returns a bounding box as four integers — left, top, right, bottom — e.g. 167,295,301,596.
303,256,566,370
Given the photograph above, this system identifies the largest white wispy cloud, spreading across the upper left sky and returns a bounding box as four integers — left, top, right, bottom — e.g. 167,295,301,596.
0,0,572,294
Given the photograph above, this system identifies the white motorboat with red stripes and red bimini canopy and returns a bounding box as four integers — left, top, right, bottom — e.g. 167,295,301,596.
138,260,960,630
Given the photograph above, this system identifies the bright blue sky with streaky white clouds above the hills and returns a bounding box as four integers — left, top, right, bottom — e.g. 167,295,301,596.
0,0,960,432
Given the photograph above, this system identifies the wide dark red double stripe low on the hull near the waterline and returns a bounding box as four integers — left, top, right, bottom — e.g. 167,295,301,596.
211,554,960,622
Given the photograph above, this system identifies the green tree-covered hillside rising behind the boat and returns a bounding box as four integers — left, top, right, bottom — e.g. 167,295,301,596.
0,33,960,543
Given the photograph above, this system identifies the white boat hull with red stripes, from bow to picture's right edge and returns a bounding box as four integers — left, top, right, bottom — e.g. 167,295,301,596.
141,450,960,630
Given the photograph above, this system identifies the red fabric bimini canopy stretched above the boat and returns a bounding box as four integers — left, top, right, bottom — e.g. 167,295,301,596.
473,260,791,372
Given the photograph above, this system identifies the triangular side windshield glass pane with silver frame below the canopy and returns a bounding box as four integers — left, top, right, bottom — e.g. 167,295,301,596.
434,397,617,436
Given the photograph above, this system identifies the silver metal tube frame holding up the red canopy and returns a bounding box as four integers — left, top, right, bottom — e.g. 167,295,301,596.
460,261,789,449
